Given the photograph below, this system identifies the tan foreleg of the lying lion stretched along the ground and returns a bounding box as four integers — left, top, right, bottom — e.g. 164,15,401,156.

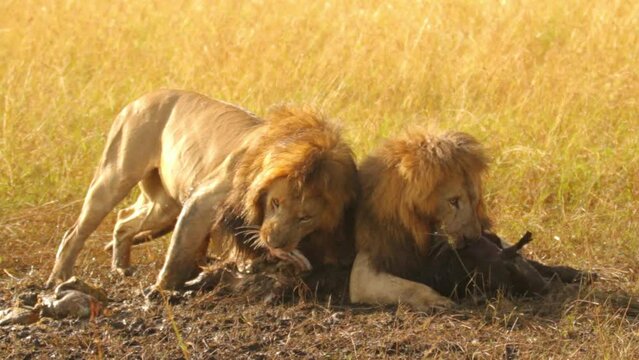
349,252,454,311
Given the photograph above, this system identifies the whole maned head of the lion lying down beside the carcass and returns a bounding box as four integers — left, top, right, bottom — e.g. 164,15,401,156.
357,129,489,276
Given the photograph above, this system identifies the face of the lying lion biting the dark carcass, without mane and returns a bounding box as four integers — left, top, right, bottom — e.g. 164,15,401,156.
431,175,481,248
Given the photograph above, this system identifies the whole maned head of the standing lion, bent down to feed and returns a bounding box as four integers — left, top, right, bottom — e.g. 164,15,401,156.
220,107,358,268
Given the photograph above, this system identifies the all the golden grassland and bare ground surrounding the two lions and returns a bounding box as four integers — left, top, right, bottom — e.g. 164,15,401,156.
0,0,639,359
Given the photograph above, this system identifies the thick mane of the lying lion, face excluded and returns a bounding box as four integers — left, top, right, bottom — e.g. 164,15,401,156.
356,128,490,279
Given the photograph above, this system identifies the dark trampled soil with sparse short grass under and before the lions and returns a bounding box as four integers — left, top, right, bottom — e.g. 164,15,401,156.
0,205,639,359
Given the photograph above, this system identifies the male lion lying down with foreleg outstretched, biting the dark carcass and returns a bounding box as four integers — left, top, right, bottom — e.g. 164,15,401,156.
350,129,490,310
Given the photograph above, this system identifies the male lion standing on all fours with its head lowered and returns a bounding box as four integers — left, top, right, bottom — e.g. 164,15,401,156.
48,90,357,289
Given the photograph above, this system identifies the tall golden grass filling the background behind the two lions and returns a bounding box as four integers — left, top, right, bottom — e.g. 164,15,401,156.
0,0,639,272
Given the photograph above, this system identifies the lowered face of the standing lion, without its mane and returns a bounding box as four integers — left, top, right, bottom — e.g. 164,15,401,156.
260,178,326,251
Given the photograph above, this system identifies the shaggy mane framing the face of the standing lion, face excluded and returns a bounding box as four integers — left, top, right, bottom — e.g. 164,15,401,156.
214,105,359,266
